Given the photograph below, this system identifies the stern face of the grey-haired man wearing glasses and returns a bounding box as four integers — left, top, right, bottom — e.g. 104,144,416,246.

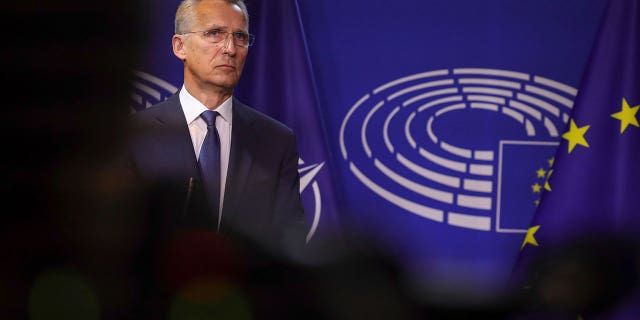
180,0,248,90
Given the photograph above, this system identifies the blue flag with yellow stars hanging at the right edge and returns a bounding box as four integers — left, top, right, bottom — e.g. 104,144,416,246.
513,0,640,319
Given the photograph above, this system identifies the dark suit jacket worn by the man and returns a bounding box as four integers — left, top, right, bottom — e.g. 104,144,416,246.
128,94,306,251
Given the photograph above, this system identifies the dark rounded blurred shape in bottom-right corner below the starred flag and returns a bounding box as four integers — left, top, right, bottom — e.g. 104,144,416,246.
516,234,640,319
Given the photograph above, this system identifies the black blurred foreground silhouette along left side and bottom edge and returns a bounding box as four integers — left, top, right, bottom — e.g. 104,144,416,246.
0,0,639,320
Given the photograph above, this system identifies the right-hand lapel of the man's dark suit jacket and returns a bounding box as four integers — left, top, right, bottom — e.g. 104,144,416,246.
222,98,255,227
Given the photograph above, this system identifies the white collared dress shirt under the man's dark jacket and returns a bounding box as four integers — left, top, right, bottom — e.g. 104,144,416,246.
179,85,233,228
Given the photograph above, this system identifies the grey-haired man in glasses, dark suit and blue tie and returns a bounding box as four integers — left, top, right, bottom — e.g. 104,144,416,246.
129,0,306,252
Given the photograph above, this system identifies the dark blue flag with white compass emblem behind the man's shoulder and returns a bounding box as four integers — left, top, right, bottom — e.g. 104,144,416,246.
234,0,342,245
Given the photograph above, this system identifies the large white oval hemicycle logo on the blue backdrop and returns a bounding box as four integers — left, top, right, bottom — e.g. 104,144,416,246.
339,68,577,233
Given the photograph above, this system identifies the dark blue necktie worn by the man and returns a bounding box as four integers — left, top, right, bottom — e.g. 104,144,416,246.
198,110,220,222
